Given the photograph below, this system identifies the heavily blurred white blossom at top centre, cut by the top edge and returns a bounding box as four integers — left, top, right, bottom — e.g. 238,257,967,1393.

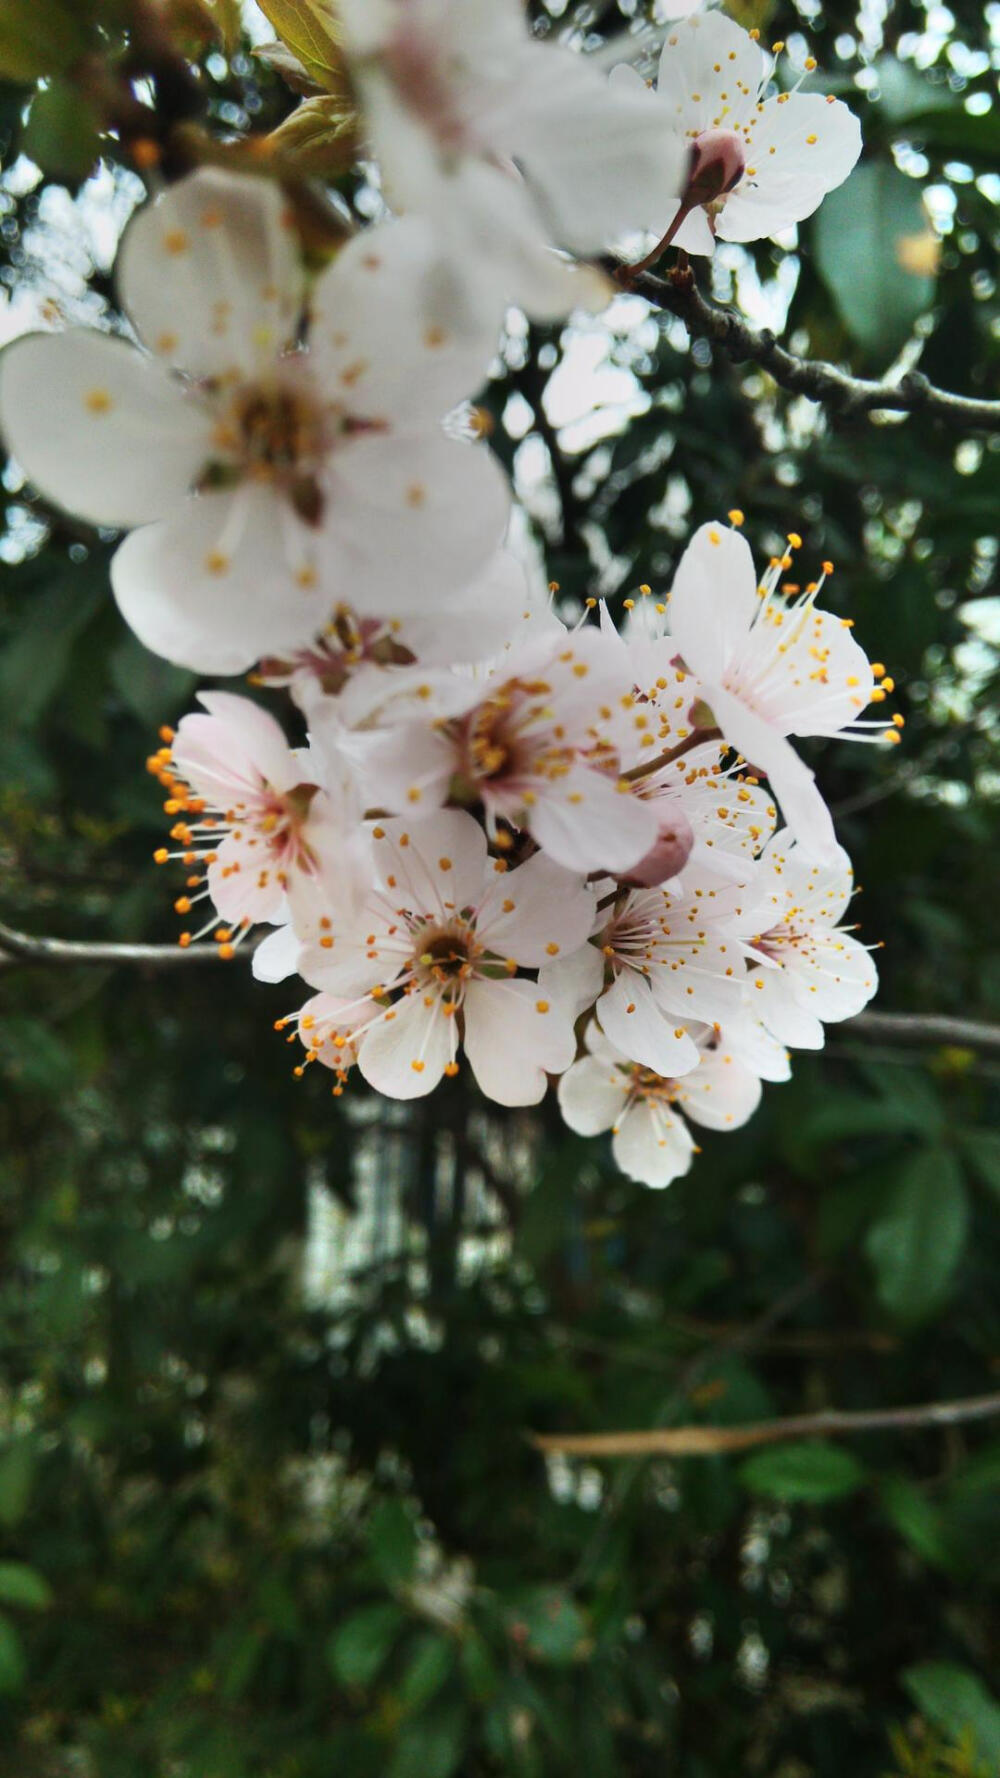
340,0,685,320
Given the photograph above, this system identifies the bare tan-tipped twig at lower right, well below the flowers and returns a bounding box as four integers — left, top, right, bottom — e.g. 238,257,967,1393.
530,1394,1000,1456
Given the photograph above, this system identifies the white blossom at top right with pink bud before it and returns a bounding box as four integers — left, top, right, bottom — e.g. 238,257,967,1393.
612,12,861,254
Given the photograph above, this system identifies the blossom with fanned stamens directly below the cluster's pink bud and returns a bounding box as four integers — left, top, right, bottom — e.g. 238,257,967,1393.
541,866,753,1077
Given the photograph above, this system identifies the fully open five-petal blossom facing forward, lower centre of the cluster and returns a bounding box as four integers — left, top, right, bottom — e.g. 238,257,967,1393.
299,809,594,1106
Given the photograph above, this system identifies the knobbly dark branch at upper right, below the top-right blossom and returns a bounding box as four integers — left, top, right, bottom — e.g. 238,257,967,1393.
614,265,1000,432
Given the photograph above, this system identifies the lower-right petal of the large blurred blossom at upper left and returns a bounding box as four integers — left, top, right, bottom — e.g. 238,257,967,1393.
319,430,511,615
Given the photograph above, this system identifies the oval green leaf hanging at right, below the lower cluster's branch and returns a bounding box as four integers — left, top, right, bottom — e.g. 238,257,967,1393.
865,1149,968,1323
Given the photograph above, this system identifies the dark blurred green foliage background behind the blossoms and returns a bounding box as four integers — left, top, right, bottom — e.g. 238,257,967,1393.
0,0,1000,1778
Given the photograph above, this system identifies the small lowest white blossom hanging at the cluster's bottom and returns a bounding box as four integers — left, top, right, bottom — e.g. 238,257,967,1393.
559,1024,760,1186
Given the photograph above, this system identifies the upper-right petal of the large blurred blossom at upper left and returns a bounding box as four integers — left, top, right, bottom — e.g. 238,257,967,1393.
310,217,496,425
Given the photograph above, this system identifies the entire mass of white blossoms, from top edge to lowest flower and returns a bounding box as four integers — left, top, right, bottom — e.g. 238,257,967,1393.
0,10,879,1186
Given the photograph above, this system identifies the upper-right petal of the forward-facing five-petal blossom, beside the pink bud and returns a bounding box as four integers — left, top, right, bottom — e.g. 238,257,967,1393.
477,852,594,969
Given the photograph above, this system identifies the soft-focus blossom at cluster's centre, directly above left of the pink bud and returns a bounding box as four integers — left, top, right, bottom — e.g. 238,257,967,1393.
327,628,658,871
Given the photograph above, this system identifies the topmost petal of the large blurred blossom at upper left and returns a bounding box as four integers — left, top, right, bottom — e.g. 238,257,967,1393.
117,167,302,377
